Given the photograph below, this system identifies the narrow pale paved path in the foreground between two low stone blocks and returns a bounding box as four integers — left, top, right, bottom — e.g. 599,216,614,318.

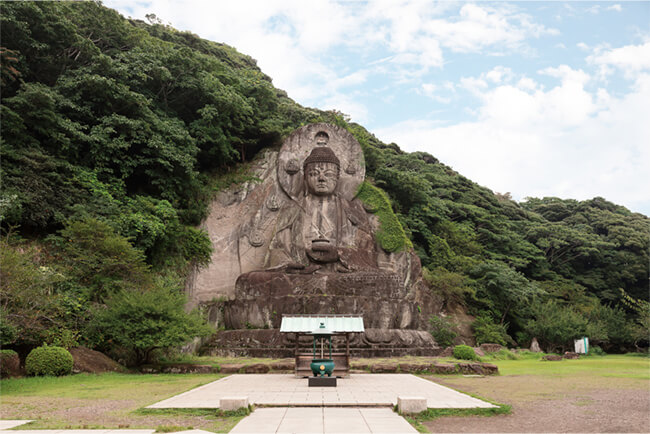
230,407,417,434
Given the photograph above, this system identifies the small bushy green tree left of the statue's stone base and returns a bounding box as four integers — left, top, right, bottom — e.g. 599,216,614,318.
89,285,212,365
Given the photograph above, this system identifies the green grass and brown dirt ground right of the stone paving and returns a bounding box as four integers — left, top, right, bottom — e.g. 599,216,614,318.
414,354,650,432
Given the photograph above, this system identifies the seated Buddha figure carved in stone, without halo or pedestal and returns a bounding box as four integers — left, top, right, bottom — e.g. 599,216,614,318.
265,146,377,273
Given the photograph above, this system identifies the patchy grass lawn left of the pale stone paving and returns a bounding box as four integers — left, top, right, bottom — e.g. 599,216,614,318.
0,373,243,432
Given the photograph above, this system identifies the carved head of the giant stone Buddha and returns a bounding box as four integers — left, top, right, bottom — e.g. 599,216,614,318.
303,146,341,196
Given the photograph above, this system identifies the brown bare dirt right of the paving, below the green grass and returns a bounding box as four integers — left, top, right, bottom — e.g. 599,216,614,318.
424,376,650,433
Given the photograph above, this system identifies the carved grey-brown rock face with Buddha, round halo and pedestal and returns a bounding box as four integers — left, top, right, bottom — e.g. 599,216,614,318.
187,124,440,354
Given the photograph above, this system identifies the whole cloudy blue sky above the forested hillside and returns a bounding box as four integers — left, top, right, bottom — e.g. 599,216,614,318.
104,0,650,215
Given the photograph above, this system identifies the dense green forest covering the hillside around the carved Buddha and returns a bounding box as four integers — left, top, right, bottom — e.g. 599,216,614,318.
0,2,650,363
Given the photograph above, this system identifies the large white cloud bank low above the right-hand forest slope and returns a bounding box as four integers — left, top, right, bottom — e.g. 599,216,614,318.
373,66,650,211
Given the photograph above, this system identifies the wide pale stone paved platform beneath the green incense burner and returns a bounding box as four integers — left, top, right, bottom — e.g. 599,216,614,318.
147,374,494,408
